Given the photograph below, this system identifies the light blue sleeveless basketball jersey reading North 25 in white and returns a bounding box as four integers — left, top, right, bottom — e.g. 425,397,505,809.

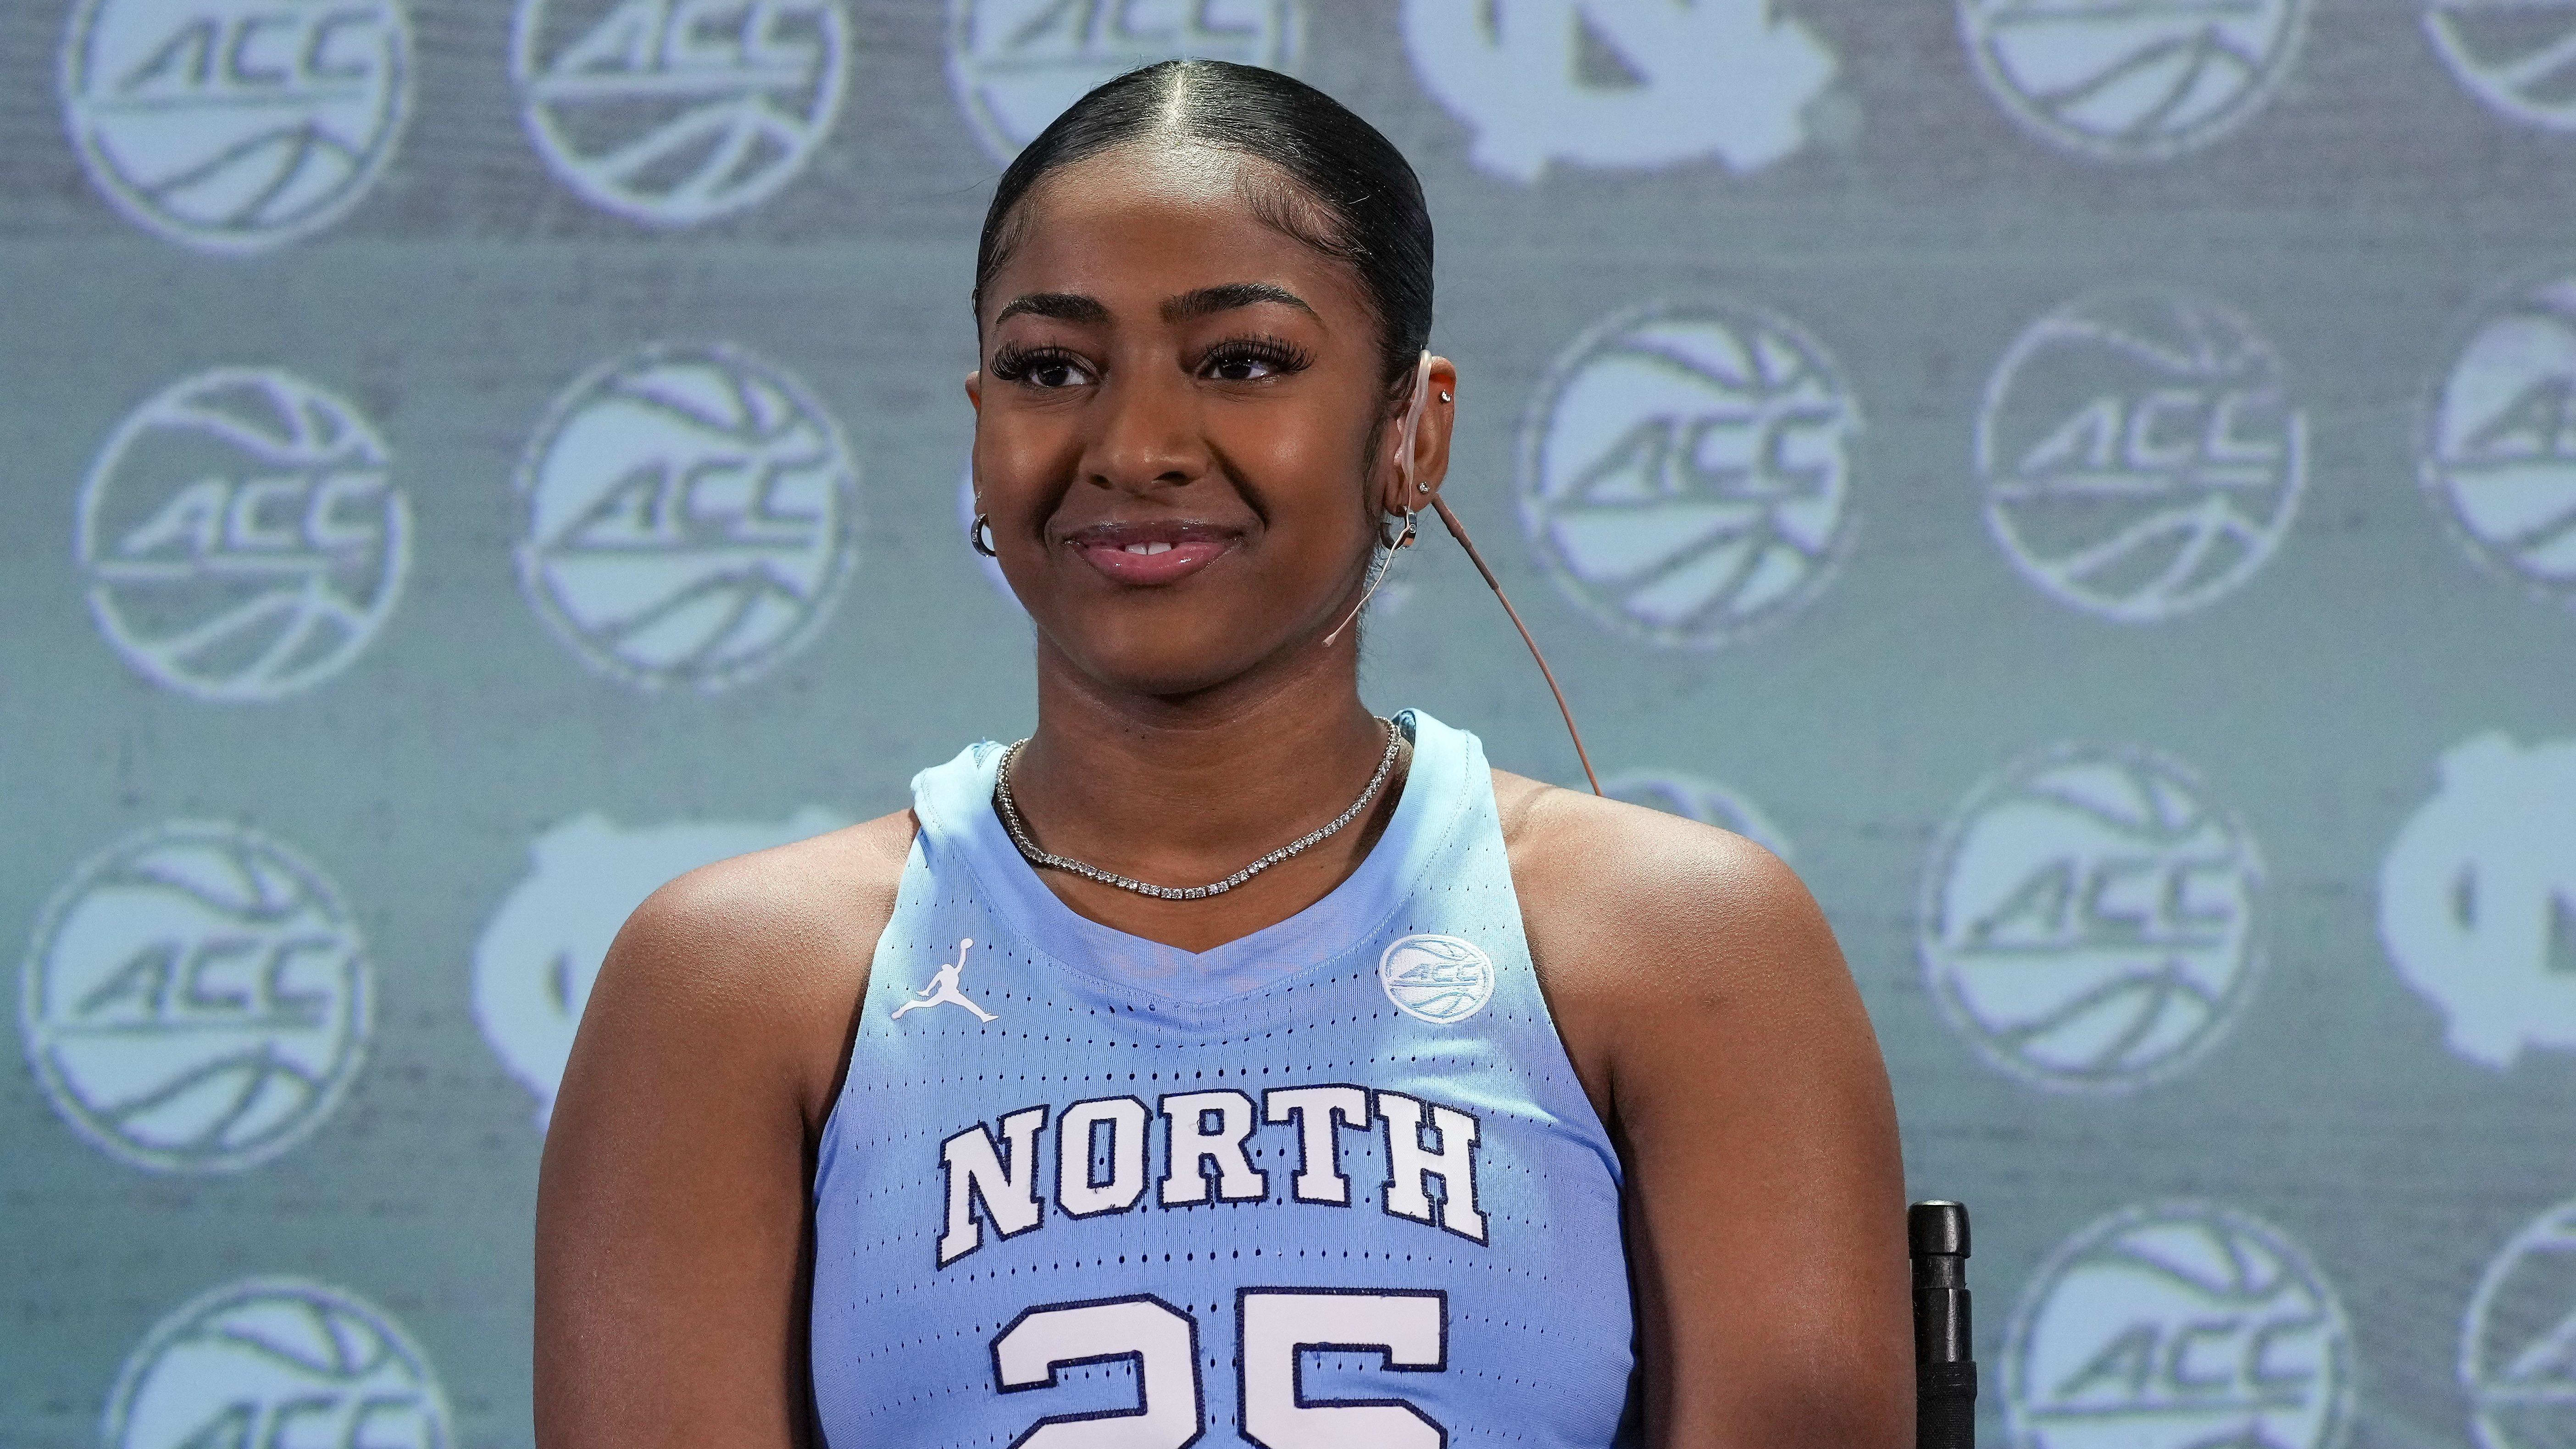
811,711,1636,1449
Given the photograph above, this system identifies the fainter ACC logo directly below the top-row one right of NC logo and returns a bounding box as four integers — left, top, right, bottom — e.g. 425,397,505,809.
1976,289,2308,624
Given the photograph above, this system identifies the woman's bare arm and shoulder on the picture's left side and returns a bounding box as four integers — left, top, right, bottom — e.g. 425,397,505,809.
536,812,912,1449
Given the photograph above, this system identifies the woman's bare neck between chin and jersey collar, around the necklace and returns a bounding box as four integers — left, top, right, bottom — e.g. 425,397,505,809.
1010,634,1401,951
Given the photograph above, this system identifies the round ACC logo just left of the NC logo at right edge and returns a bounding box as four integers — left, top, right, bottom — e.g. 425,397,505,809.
1916,745,2262,1091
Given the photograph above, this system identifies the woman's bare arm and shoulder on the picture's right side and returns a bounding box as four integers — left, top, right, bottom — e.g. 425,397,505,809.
1497,776,1914,1449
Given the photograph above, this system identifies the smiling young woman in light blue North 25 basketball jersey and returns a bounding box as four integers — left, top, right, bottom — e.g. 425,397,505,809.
536,62,1911,1449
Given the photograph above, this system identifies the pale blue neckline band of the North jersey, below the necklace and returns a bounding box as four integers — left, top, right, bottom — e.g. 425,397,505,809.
912,709,1473,1003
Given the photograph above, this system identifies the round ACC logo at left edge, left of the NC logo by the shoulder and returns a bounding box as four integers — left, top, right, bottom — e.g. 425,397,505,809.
18,822,373,1173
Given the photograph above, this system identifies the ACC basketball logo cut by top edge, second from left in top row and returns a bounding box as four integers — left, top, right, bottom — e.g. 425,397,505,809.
510,0,850,227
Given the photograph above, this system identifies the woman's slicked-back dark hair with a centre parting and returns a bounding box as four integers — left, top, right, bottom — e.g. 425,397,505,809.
974,59,1432,387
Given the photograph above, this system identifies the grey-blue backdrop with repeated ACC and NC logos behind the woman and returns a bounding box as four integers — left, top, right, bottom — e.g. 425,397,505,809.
0,0,2576,1449
